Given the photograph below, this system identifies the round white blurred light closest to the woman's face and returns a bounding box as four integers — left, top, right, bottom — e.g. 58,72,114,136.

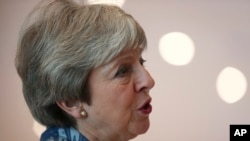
159,32,195,66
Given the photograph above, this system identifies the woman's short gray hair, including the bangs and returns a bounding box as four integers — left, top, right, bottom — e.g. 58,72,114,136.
16,0,147,126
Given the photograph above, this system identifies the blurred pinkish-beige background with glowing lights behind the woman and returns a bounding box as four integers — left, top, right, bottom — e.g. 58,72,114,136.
0,0,250,141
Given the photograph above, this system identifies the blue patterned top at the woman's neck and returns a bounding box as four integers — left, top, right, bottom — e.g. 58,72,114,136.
40,127,88,141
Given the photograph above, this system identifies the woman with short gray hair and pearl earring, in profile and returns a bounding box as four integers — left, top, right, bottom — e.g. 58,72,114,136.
16,0,154,141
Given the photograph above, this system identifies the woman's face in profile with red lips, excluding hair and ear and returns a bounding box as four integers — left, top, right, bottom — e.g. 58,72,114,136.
80,51,154,141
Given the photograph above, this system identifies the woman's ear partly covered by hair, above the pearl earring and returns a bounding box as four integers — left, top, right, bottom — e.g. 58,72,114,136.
56,101,83,118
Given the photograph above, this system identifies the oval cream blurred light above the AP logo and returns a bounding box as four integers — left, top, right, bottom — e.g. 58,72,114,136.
216,67,247,104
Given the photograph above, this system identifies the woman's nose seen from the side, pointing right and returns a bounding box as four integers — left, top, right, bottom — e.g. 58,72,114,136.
135,66,155,92
